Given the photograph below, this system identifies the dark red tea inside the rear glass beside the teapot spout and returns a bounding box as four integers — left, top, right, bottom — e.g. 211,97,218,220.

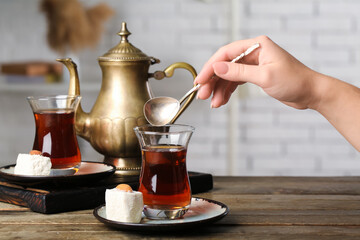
33,109,81,168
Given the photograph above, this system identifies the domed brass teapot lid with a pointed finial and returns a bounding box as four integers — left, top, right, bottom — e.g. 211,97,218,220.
98,22,159,62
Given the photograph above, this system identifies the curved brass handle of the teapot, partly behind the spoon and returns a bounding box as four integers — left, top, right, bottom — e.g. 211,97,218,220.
153,62,197,123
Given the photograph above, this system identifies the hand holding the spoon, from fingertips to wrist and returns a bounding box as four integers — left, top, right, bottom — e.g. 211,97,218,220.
195,36,317,109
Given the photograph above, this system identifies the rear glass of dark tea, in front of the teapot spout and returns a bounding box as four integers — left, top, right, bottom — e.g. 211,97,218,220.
27,95,81,169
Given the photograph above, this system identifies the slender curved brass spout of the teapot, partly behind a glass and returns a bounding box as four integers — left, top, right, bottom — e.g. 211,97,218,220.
56,58,90,141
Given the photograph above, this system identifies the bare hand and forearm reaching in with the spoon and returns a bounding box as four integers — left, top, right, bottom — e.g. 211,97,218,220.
195,36,360,151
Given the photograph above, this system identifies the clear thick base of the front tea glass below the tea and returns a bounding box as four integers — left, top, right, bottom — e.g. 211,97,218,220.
143,205,190,219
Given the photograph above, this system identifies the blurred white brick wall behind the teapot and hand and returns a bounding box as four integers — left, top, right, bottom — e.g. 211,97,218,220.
0,0,360,176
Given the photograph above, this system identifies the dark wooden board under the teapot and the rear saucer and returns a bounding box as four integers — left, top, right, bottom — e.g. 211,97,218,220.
0,172,213,213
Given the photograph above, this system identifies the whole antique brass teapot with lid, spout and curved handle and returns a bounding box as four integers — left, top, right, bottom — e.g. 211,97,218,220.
57,22,196,177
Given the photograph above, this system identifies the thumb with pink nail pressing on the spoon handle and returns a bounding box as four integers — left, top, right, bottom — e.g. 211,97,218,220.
212,62,261,85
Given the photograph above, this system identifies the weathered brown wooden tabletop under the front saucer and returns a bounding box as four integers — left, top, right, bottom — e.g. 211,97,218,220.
0,177,360,240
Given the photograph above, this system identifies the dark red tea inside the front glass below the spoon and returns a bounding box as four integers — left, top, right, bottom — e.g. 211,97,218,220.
139,146,191,210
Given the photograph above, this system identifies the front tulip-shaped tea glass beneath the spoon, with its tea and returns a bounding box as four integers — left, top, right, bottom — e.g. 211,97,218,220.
134,124,194,219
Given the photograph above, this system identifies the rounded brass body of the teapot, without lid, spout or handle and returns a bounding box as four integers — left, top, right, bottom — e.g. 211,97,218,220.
88,61,150,165
